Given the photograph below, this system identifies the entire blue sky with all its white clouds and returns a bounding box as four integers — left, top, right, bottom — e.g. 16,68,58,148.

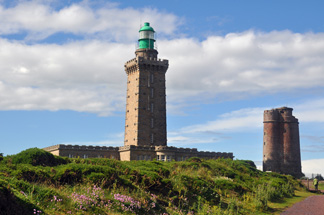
0,0,324,174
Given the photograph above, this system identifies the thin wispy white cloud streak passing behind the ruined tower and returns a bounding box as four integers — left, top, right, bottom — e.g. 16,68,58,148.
168,99,324,146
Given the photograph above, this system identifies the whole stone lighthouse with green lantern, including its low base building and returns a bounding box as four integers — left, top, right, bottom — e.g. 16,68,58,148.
45,22,234,161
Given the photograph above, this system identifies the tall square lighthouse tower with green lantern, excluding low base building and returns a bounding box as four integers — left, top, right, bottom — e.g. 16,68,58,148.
124,23,169,146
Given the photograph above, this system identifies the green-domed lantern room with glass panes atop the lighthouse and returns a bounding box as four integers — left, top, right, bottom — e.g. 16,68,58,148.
138,22,155,49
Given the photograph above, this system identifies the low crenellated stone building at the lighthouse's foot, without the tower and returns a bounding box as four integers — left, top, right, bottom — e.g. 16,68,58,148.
44,144,234,161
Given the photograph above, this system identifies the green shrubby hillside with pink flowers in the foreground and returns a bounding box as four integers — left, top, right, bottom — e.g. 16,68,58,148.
0,148,301,215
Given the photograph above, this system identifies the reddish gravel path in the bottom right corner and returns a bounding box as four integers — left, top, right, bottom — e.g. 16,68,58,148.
281,196,324,215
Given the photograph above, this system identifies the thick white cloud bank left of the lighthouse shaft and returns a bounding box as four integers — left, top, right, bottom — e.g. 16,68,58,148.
0,39,133,115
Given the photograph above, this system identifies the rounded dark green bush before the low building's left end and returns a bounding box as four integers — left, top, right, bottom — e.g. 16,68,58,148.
12,148,67,166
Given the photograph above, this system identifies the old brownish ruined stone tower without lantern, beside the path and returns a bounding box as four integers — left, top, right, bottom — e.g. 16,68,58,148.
263,107,303,178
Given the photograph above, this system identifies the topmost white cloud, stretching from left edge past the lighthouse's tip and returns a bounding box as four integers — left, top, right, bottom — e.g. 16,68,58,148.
0,1,181,41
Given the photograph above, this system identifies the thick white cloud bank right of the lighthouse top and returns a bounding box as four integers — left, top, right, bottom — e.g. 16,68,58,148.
159,31,324,100
